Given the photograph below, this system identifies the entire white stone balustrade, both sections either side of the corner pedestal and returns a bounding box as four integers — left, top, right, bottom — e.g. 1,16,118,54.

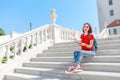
0,24,80,63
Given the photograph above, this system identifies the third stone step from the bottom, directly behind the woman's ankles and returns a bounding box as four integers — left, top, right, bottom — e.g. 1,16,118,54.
23,62,120,72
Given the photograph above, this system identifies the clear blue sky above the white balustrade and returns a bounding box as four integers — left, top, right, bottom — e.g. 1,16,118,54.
0,0,99,34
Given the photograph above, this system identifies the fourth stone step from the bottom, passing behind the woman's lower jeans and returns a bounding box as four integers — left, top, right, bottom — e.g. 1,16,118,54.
31,55,120,63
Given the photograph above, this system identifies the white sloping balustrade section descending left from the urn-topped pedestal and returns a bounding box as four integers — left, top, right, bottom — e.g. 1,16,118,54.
0,25,48,63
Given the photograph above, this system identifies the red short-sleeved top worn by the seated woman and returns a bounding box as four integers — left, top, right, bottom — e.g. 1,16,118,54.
80,34,94,51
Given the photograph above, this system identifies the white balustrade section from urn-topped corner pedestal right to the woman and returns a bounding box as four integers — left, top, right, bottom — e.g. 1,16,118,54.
50,24,81,43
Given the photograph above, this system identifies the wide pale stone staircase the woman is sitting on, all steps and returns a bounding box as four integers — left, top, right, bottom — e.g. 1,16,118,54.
3,38,120,80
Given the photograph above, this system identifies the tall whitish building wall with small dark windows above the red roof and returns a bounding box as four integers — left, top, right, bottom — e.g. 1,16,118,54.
97,0,120,32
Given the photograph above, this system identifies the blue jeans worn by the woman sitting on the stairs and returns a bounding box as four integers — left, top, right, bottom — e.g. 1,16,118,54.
74,50,95,64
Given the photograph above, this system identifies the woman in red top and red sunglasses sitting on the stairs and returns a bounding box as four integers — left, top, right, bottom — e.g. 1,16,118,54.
65,23,95,73
